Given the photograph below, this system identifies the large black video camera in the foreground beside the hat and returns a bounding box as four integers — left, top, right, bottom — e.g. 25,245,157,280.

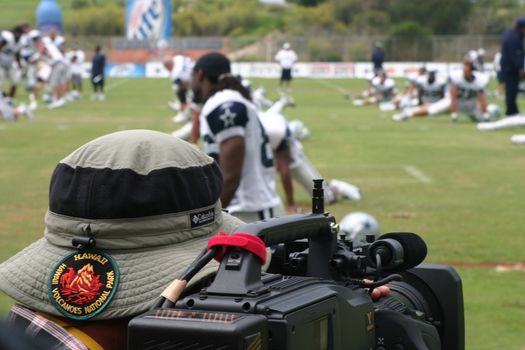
128,180,464,350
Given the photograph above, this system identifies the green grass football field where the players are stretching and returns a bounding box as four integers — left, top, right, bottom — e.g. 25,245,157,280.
0,79,525,350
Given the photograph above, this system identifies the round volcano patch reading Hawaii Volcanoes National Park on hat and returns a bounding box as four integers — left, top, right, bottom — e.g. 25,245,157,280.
49,250,119,320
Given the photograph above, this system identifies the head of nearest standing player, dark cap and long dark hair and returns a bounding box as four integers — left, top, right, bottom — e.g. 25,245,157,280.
191,52,251,103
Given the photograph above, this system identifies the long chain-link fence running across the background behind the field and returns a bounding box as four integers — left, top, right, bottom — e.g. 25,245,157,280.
67,34,500,62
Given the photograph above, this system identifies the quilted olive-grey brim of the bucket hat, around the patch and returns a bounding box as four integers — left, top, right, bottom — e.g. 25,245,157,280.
0,213,243,320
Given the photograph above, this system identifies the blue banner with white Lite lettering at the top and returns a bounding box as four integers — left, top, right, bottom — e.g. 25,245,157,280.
126,0,171,40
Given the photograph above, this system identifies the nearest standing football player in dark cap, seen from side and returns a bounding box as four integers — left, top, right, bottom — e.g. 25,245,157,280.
191,52,283,222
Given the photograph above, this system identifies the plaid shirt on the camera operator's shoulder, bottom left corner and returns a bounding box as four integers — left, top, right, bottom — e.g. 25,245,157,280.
7,304,89,350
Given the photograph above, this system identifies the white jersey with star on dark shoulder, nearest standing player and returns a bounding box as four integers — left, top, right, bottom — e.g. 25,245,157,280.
199,90,281,213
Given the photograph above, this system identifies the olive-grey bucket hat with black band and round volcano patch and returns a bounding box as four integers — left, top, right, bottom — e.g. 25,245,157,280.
0,130,242,320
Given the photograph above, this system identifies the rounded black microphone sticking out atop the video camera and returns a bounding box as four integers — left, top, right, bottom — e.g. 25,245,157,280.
368,232,427,271
